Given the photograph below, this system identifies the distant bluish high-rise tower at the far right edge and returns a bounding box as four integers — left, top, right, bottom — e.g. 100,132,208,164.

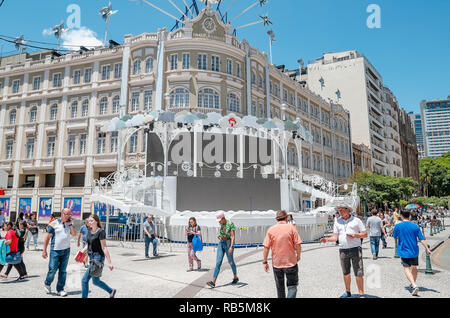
420,96,450,158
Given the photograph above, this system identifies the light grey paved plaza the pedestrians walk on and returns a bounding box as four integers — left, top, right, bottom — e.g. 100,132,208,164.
0,224,450,298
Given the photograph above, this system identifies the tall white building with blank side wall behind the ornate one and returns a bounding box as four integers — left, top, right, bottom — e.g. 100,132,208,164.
302,50,402,176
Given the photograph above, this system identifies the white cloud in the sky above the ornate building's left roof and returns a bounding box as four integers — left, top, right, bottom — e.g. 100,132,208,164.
42,27,103,50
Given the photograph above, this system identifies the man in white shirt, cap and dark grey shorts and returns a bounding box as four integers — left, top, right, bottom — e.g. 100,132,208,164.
320,204,367,298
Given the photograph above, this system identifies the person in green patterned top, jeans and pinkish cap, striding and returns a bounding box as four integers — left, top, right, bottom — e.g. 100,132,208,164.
206,212,239,288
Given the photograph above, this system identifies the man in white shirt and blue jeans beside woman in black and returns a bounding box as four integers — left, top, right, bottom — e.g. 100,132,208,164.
42,209,77,297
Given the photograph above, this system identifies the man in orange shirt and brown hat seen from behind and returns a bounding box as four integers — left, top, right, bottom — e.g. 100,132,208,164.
263,211,302,298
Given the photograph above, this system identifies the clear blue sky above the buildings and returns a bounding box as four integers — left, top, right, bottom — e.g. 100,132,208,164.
0,0,450,112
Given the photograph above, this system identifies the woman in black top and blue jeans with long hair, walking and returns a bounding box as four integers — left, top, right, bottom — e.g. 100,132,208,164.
81,214,116,298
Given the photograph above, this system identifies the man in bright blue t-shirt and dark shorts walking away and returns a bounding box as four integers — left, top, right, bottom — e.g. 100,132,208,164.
393,210,431,296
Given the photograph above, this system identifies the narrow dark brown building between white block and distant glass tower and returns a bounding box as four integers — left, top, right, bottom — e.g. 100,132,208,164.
398,109,419,182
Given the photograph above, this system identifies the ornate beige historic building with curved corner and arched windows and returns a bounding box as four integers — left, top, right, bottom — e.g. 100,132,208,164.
0,7,352,221
